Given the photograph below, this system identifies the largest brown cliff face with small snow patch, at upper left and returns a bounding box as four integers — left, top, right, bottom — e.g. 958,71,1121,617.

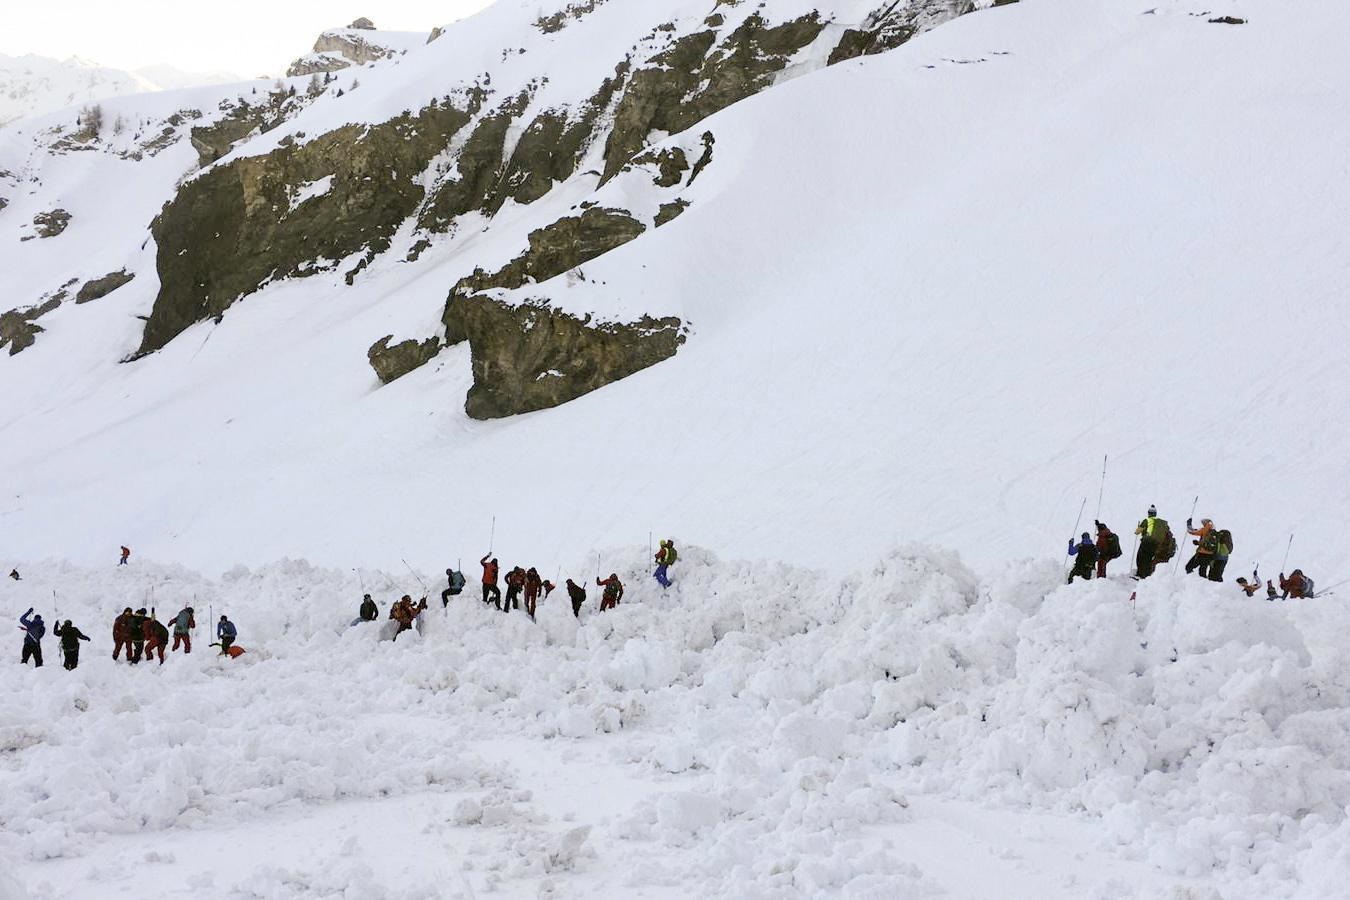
138,105,470,355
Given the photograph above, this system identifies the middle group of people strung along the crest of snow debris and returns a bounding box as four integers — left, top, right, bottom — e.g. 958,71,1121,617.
352,540,679,640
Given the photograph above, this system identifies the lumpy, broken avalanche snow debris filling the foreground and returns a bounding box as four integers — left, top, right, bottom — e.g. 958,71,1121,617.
0,546,1350,900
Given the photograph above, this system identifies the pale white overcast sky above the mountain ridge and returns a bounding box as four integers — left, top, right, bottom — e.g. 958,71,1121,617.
0,0,491,77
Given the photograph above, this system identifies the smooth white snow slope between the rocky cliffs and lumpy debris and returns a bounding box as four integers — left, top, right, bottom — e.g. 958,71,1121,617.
0,1,1346,583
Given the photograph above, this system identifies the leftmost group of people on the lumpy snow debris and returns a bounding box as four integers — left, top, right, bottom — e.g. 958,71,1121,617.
19,604,243,669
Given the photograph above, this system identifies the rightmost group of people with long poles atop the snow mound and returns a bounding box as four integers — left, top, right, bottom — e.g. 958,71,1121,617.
1069,506,1314,600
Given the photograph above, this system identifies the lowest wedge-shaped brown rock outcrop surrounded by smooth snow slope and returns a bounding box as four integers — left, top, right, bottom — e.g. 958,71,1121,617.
455,294,684,418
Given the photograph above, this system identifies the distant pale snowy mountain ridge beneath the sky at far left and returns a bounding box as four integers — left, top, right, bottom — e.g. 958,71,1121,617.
0,53,239,125
